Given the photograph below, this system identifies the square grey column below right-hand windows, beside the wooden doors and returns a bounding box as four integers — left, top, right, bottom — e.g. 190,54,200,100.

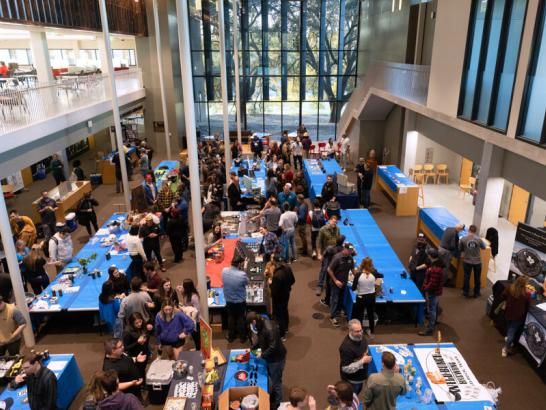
473,142,504,236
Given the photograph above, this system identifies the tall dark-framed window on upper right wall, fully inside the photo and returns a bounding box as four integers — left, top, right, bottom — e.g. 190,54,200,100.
459,0,527,132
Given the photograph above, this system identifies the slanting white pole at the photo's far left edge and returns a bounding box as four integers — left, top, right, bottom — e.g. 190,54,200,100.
0,195,35,347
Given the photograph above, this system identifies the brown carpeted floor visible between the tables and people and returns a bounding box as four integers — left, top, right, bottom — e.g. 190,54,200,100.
8,152,545,409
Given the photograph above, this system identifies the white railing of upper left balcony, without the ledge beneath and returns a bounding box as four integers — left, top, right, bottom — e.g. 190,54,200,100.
0,69,143,136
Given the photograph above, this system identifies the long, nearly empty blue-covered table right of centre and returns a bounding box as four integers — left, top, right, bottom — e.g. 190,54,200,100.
338,209,425,323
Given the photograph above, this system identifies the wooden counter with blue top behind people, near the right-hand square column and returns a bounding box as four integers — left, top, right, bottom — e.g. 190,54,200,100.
417,207,491,289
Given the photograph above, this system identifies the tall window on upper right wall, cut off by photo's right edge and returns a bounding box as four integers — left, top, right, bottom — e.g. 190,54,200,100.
519,0,546,145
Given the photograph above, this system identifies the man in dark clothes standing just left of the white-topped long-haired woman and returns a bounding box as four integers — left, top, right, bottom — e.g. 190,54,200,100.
328,242,355,327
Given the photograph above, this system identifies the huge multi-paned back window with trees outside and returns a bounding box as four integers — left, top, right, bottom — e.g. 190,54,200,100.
188,0,360,139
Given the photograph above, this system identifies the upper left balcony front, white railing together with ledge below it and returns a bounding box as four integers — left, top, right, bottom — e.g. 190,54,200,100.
0,70,145,152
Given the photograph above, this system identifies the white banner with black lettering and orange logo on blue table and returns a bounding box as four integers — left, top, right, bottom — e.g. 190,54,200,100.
414,346,492,402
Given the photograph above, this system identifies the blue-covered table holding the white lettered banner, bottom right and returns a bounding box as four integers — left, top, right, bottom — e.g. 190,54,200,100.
368,343,496,410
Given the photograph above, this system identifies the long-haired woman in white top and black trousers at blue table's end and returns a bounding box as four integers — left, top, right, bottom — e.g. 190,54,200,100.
352,257,376,340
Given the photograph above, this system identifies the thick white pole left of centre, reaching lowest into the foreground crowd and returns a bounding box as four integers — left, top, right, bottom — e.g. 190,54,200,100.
175,0,209,321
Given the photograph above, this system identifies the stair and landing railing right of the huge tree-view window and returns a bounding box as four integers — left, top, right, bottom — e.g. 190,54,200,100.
337,62,430,135
